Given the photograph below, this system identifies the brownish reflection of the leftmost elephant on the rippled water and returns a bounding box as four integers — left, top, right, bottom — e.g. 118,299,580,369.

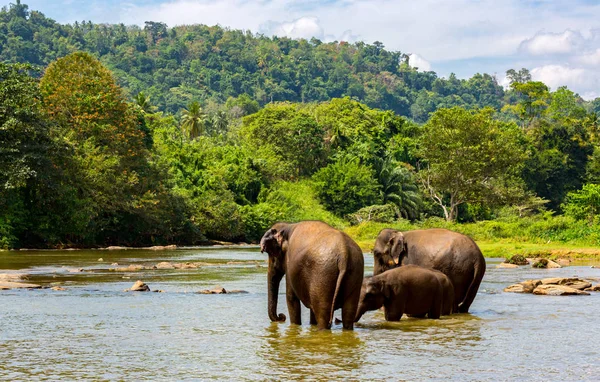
258,323,364,380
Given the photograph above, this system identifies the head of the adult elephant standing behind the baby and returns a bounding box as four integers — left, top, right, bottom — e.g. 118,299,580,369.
373,229,408,275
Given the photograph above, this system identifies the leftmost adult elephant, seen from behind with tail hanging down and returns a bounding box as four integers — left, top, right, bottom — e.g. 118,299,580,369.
260,221,364,329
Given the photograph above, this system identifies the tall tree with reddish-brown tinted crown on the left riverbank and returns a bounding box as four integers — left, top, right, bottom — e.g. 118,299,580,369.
40,53,157,243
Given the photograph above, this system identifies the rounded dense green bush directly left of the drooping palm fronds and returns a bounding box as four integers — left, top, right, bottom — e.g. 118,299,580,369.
313,157,380,216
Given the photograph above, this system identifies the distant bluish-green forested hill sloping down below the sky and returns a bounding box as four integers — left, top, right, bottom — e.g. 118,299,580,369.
0,1,505,122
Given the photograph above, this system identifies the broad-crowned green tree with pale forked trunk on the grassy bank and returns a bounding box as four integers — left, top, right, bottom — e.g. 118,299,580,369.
417,107,525,221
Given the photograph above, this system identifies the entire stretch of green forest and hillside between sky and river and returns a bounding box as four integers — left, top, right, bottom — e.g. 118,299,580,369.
0,1,600,248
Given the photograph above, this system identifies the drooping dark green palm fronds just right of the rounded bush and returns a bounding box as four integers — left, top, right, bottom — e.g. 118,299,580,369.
375,155,421,219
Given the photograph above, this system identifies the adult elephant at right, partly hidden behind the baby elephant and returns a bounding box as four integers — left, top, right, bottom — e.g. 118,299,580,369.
373,228,485,313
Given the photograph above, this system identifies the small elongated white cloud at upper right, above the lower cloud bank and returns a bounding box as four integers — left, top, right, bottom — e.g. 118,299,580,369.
519,29,585,56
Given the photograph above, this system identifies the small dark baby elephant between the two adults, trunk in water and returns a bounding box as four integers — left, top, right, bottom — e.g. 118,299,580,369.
354,265,454,322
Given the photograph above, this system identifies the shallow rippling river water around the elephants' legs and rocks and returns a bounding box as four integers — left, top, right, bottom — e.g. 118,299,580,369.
0,247,600,381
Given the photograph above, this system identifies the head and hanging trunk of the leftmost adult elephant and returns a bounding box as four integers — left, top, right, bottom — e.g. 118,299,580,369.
260,223,289,321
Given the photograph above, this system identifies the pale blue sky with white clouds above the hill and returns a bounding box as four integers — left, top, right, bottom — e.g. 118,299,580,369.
22,0,600,99
